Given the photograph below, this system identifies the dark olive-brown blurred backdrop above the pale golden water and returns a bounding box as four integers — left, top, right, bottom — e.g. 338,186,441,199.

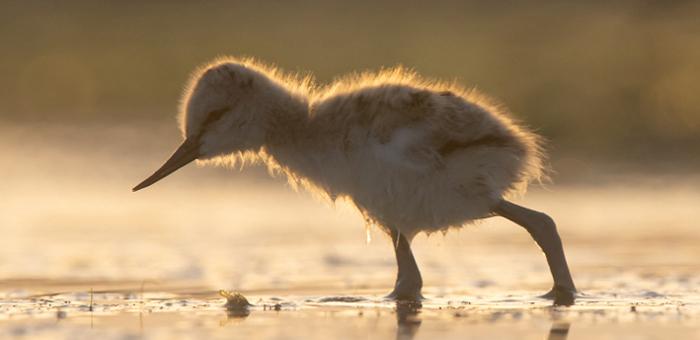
0,1,700,168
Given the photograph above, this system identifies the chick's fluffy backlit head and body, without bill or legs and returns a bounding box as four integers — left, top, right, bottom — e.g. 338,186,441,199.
180,58,543,237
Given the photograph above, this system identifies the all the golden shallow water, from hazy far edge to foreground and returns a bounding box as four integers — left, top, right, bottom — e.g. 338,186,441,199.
0,128,700,339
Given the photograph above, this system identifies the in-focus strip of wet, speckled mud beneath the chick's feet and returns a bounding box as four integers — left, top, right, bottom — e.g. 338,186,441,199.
0,284,700,339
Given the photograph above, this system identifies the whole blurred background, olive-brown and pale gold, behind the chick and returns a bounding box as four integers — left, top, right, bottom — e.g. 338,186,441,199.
0,1,700,292
